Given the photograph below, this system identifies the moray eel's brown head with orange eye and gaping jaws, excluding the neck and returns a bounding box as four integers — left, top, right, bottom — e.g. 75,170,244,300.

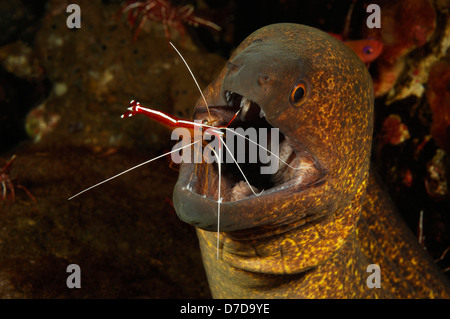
174,24,373,242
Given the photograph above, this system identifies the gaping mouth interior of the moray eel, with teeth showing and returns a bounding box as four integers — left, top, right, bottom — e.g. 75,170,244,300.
186,91,324,202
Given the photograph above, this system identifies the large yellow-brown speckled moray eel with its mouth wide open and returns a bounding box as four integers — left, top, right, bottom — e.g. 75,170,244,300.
174,24,450,298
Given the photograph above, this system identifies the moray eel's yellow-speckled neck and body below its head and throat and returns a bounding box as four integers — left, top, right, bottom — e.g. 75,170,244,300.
197,171,450,298
